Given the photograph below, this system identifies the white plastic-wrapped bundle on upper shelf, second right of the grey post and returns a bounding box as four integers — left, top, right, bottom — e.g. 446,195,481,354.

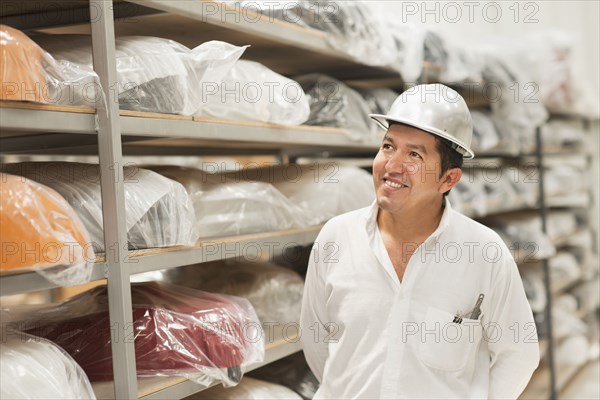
197,60,310,125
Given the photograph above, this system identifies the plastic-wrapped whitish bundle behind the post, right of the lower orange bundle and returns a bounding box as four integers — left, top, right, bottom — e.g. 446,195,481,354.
2,162,198,251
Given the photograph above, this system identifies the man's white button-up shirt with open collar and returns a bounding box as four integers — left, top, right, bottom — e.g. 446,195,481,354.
301,201,539,399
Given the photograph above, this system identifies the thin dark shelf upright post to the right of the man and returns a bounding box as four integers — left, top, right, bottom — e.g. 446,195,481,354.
535,126,556,400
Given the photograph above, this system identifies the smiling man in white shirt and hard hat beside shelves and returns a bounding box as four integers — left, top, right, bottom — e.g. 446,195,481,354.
301,84,539,399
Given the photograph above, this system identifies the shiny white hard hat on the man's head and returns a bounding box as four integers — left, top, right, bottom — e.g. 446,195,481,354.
369,83,475,158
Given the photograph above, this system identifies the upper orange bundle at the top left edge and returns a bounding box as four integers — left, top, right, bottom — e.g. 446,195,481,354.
0,25,47,103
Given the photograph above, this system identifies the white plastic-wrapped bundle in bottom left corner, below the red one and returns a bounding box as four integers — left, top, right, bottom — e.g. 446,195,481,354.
0,332,96,400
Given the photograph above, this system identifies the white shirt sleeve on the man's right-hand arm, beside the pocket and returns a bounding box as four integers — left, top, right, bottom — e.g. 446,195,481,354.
482,255,540,399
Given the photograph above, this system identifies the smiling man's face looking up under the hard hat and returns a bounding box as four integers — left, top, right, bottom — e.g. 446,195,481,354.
373,125,447,213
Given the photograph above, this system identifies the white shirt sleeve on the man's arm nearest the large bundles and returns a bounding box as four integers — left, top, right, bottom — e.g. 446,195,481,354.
300,242,329,382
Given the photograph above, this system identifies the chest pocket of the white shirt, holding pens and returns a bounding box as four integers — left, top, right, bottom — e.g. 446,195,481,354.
419,307,483,372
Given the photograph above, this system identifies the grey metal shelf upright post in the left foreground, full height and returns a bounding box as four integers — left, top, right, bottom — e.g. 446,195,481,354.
90,0,137,399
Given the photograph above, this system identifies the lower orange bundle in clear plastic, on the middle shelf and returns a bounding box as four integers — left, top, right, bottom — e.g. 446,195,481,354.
0,173,95,286
